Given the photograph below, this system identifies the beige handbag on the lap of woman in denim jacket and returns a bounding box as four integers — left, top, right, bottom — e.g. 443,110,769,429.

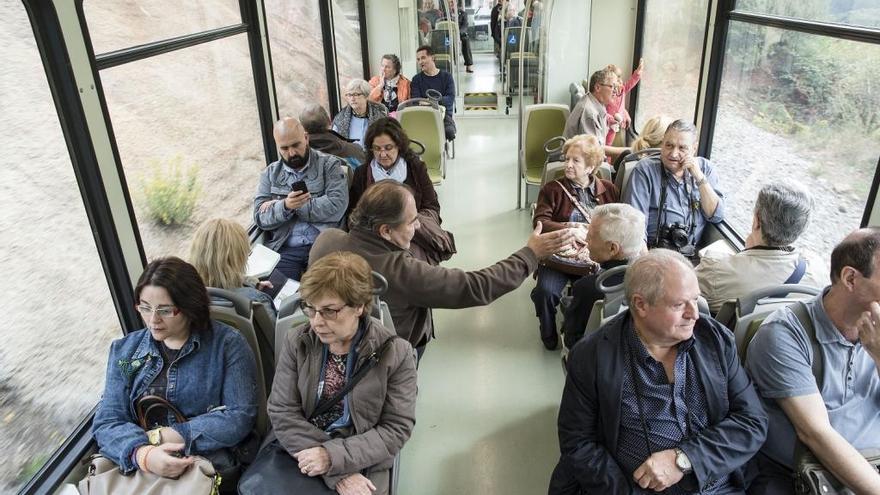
78,455,221,495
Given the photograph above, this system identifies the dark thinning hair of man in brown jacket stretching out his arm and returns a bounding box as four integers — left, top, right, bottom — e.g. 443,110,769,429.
348,180,413,233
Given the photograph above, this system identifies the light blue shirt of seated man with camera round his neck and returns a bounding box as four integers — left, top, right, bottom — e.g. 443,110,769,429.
622,156,724,246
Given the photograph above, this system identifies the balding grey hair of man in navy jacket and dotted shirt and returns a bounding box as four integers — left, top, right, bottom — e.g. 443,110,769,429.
623,249,696,307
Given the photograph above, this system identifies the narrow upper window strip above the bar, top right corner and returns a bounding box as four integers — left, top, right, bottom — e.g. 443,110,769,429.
736,0,880,27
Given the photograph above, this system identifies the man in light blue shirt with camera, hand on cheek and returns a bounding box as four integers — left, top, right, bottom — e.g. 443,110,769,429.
622,119,724,258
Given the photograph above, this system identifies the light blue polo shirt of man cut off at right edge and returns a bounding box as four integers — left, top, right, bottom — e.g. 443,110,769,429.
746,287,880,467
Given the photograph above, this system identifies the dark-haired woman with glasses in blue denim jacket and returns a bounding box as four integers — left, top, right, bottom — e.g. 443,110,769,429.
92,257,257,478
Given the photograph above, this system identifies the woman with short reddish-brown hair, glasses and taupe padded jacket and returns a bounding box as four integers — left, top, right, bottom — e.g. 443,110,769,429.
239,253,416,495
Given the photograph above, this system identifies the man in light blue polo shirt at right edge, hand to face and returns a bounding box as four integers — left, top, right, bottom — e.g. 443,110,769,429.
746,227,880,494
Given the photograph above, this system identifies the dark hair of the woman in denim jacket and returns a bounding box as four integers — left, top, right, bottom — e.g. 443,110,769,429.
134,256,211,332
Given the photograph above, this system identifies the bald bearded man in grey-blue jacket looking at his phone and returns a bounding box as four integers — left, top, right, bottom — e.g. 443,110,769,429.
254,117,348,280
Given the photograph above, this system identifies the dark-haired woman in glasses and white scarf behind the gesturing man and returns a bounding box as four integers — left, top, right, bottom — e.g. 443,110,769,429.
348,117,455,265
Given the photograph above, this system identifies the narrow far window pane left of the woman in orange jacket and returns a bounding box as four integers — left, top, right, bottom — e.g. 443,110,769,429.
331,0,368,90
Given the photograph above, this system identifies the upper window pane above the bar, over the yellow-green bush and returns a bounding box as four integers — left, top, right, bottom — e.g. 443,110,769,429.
83,0,241,54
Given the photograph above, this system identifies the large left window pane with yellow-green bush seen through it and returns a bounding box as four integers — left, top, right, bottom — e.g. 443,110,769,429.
100,34,266,259
